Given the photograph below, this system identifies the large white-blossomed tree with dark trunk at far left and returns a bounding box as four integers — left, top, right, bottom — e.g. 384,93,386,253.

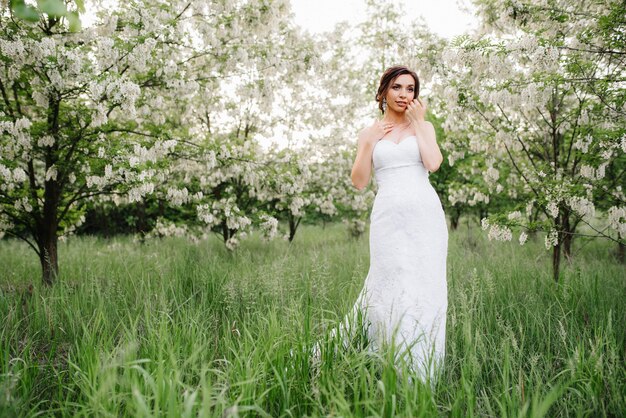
0,0,310,284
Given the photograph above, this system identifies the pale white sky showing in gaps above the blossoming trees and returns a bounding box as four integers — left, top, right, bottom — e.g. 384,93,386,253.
291,0,476,39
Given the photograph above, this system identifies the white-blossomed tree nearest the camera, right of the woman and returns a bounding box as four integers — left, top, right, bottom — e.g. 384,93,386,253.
440,0,626,280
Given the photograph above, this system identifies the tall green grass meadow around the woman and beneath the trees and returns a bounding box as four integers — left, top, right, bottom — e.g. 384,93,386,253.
0,220,626,417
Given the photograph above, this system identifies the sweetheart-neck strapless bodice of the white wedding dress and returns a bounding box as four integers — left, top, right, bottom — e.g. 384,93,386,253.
372,135,428,191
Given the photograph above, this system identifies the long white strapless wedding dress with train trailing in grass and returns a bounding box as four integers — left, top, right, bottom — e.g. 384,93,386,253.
320,136,448,384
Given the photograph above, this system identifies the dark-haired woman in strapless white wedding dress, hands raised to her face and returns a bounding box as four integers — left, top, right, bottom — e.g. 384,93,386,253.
322,66,448,384
